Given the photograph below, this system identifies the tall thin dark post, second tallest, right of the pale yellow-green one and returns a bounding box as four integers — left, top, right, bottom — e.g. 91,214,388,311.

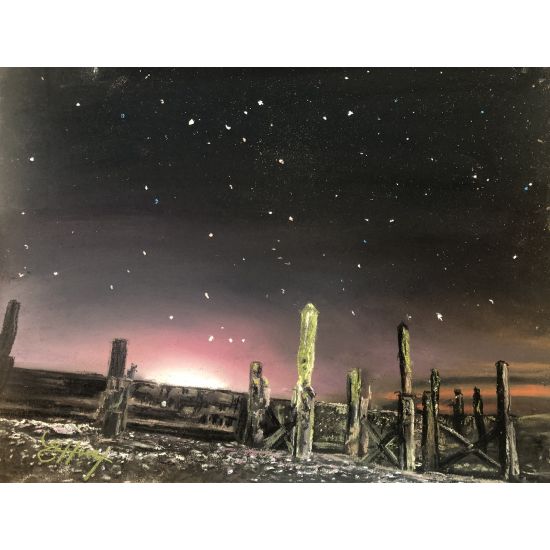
397,322,415,470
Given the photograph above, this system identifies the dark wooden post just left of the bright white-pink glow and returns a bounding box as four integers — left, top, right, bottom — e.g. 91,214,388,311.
97,338,132,437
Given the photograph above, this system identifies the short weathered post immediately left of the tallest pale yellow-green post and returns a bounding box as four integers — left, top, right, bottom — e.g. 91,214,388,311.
243,361,270,447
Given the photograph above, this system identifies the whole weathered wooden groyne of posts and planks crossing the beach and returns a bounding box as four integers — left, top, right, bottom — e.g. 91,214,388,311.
0,301,521,481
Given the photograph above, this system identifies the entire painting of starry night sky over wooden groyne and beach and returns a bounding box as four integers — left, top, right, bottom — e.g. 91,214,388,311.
0,67,550,483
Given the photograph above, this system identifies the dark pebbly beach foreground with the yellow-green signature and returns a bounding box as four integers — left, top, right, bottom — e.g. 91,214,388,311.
0,418,500,483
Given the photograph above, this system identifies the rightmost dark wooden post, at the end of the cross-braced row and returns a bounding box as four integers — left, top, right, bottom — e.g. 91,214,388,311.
495,361,519,481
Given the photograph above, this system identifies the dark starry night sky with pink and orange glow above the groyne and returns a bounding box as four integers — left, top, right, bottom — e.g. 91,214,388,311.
0,68,550,413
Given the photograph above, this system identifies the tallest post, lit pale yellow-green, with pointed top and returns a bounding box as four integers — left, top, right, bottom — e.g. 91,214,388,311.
292,304,319,459
